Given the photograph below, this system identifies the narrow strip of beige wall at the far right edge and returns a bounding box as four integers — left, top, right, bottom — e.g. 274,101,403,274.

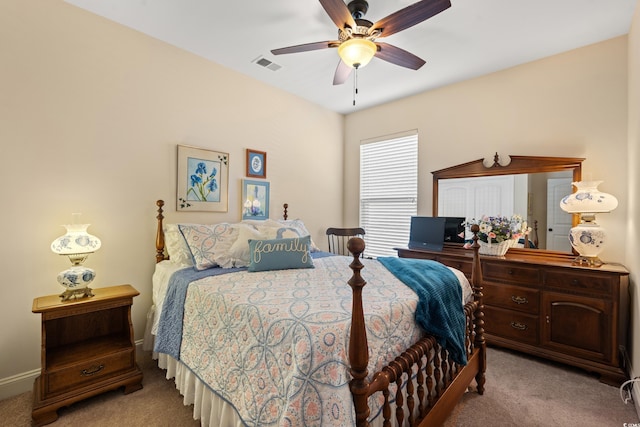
625,0,640,412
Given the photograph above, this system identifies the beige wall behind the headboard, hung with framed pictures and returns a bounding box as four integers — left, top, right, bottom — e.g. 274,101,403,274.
0,0,344,397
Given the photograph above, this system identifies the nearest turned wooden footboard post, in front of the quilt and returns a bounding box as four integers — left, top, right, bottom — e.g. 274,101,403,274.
347,237,369,427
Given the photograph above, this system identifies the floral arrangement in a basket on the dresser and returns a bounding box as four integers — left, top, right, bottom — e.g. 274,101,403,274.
466,215,531,256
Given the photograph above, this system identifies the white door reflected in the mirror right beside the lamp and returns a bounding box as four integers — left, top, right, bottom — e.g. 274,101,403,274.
546,178,572,252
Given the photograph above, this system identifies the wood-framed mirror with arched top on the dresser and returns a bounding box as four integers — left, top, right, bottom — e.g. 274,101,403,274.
432,153,584,252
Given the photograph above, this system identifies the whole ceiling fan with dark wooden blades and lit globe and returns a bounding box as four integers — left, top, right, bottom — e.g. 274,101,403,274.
271,0,451,85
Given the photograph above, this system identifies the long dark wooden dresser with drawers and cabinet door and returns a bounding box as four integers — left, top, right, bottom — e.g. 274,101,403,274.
397,245,629,386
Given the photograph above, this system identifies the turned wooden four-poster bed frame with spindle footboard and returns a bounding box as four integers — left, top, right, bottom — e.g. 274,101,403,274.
156,200,486,427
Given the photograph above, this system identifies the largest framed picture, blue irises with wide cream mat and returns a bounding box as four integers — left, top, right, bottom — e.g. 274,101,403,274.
176,145,229,212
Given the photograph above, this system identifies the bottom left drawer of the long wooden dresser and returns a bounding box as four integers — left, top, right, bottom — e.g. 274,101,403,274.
484,306,538,345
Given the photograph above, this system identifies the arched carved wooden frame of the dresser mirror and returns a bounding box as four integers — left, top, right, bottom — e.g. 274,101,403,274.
431,153,585,252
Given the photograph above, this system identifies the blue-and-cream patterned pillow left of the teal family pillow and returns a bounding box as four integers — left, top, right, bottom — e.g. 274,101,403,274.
179,223,238,270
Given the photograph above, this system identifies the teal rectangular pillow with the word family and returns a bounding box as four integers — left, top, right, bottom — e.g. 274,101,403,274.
248,236,314,271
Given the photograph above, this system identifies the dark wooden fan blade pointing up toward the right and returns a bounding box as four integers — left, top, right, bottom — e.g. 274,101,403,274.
369,0,451,37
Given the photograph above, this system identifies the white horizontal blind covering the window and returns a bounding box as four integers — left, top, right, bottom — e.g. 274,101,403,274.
360,134,418,257
